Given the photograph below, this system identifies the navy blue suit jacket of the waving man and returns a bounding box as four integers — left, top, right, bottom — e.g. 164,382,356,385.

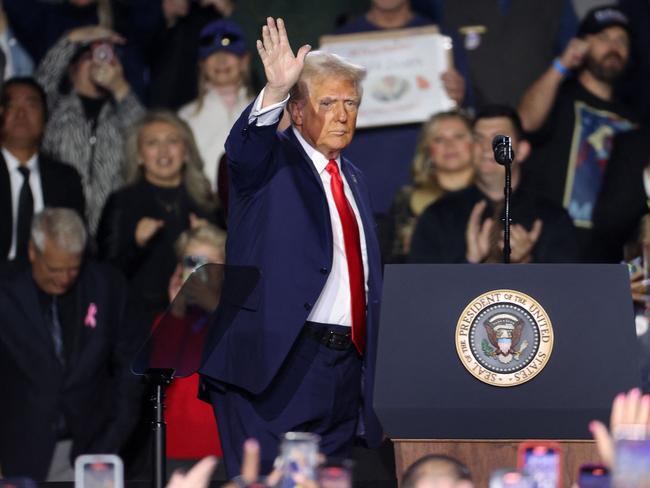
201,107,382,444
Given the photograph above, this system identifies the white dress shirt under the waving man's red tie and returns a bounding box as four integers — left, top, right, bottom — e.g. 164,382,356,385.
249,90,368,327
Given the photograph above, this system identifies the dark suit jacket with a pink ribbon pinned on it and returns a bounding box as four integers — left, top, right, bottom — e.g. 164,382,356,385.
0,262,140,481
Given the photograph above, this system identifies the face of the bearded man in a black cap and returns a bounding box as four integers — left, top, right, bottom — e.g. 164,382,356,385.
585,26,630,83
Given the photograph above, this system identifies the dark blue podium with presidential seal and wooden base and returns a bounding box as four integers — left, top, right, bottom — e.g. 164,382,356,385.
374,264,641,486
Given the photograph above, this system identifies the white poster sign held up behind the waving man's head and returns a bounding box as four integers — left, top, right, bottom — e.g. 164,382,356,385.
320,26,456,127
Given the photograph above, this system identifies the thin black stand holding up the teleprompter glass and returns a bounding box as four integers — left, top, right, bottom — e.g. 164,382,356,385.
145,368,174,488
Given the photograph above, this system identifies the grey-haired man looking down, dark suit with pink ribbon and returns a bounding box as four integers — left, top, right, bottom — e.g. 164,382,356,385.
0,208,140,481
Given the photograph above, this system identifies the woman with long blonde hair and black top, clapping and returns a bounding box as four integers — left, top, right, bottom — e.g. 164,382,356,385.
97,111,218,318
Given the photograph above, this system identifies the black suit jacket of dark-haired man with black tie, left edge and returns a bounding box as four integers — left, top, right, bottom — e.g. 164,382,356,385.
0,152,86,261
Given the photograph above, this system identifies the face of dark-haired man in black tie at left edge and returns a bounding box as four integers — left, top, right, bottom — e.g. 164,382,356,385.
2,84,45,147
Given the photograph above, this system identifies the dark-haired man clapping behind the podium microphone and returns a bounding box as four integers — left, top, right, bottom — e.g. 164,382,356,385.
409,105,578,263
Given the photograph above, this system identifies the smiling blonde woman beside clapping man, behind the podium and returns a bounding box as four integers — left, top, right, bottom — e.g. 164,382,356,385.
383,111,474,263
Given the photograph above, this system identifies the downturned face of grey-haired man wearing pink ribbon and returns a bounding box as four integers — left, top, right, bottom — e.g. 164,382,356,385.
29,238,81,295
